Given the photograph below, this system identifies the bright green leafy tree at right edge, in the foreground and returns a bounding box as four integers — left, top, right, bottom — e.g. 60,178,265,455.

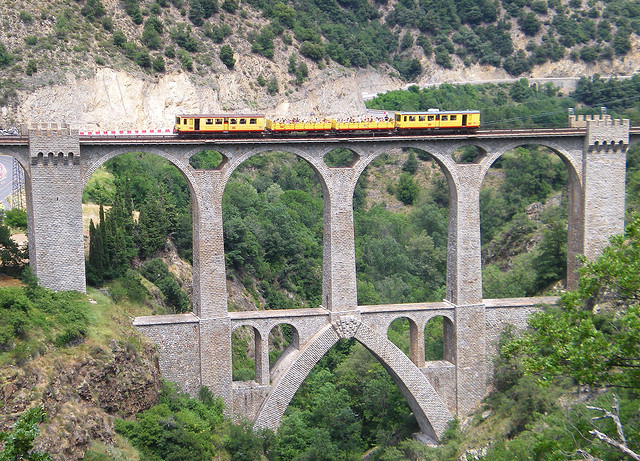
505,219,640,390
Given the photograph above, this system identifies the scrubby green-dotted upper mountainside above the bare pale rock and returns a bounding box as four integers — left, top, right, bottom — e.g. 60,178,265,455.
0,0,640,108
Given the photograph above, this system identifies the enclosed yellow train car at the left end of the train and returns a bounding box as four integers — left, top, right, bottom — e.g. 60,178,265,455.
174,114,267,136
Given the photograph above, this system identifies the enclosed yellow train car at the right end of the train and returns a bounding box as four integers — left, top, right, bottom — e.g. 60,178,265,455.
395,109,480,132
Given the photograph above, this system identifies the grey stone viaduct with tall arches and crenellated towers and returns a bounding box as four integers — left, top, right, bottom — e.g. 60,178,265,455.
0,116,635,440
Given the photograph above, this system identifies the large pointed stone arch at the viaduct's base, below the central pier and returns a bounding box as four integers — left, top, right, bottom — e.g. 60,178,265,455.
255,324,452,440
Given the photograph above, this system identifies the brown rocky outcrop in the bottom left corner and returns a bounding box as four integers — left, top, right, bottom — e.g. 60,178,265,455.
0,340,160,461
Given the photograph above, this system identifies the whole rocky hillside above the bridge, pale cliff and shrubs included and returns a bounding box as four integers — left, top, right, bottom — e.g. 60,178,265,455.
0,0,640,129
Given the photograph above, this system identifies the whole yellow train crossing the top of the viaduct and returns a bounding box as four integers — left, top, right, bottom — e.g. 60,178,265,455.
174,109,480,137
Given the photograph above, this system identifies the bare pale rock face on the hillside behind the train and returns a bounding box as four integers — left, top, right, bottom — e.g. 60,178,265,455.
11,65,402,130
